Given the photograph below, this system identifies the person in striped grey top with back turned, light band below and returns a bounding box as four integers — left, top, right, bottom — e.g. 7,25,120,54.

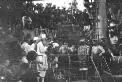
78,38,90,80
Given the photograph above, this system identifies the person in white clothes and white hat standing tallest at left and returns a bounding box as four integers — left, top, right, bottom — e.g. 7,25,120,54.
33,33,48,82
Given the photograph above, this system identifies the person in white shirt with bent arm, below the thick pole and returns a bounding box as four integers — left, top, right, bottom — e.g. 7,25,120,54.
91,40,105,76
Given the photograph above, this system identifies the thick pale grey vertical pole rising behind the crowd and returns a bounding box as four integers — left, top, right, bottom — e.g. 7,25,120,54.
96,0,106,40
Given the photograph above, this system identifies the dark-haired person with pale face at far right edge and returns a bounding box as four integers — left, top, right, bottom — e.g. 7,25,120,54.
106,31,122,75
